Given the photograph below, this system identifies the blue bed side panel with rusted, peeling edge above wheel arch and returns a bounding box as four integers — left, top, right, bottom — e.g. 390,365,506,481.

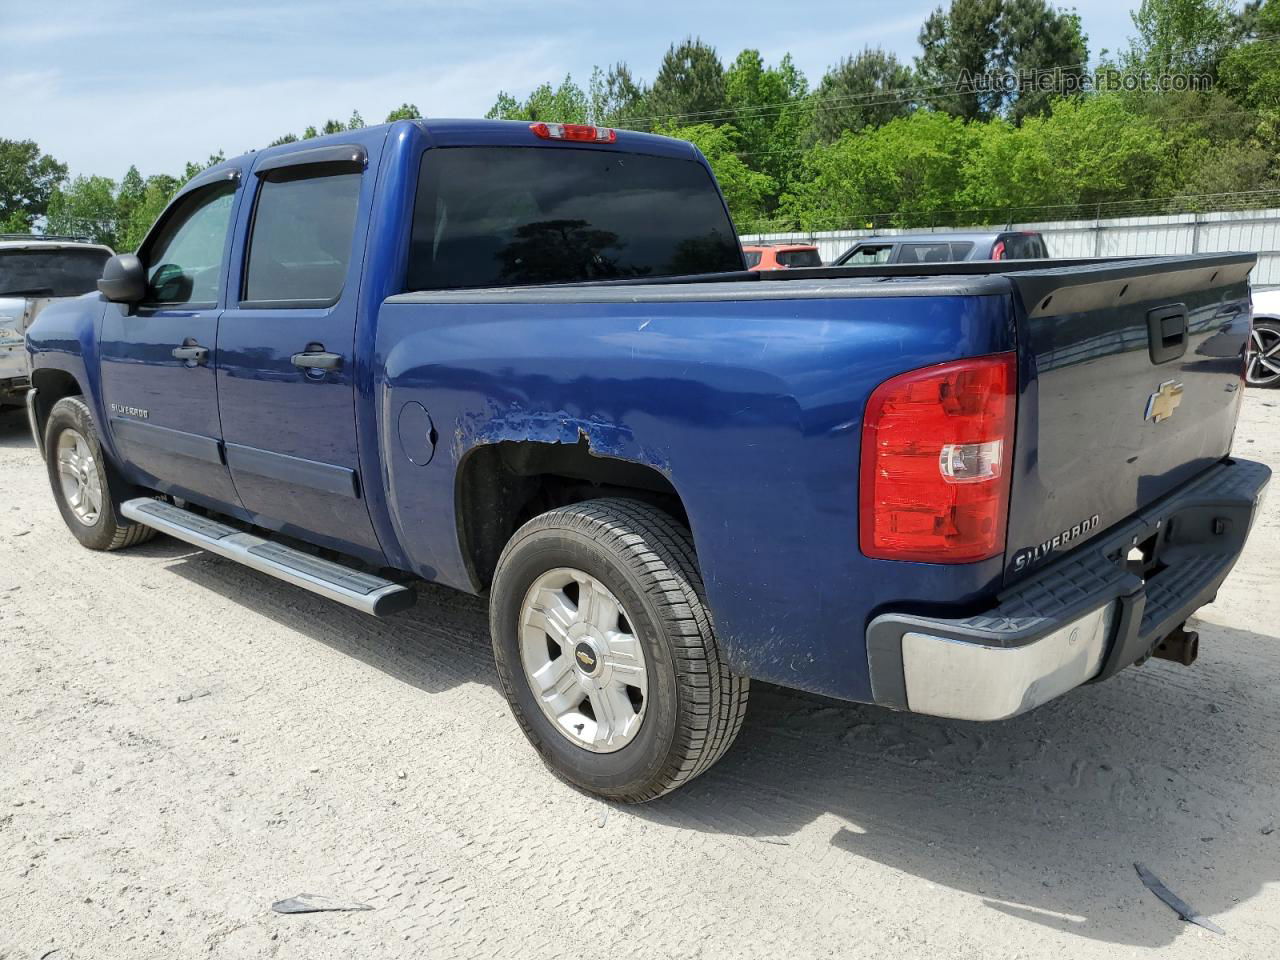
374,289,1012,700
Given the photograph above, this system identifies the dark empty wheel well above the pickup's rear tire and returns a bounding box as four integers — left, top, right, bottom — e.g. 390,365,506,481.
454,439,689,590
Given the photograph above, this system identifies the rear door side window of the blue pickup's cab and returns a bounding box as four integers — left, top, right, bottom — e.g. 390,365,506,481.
241,165,361,307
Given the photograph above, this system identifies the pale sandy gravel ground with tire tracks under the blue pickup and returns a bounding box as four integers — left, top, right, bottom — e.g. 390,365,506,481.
0,393,1280,960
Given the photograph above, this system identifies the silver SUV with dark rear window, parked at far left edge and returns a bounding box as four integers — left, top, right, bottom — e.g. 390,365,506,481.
0,234,111,406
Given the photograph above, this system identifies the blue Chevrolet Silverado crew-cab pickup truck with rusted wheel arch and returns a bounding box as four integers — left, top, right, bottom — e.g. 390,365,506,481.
20,120,1270,801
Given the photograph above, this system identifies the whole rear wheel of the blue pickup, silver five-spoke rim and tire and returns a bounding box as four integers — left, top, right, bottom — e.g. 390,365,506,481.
489,499,748,803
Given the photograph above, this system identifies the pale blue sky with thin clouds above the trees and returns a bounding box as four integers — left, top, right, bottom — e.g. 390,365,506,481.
0,0,1133,179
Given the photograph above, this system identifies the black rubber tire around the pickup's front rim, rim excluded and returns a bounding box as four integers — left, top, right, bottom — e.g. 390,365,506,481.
45,397,155,550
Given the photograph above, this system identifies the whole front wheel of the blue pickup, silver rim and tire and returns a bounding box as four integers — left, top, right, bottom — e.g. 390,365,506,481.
45,397,155,550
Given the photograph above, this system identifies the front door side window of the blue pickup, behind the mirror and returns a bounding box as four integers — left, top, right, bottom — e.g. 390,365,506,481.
142,182,236,307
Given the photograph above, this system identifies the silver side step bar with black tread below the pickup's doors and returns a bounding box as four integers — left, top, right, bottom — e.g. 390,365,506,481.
120,497,417,617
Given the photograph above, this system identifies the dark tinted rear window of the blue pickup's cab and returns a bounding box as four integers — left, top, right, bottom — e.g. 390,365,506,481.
406,147,742,291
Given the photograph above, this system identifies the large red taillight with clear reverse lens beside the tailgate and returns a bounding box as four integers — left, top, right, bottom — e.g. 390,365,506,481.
859,353,1018,563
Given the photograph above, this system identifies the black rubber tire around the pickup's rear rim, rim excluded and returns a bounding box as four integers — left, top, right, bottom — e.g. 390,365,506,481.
489,499,749,803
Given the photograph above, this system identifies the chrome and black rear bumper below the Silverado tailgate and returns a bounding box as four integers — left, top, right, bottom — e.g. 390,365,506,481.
867,461,1271,721
